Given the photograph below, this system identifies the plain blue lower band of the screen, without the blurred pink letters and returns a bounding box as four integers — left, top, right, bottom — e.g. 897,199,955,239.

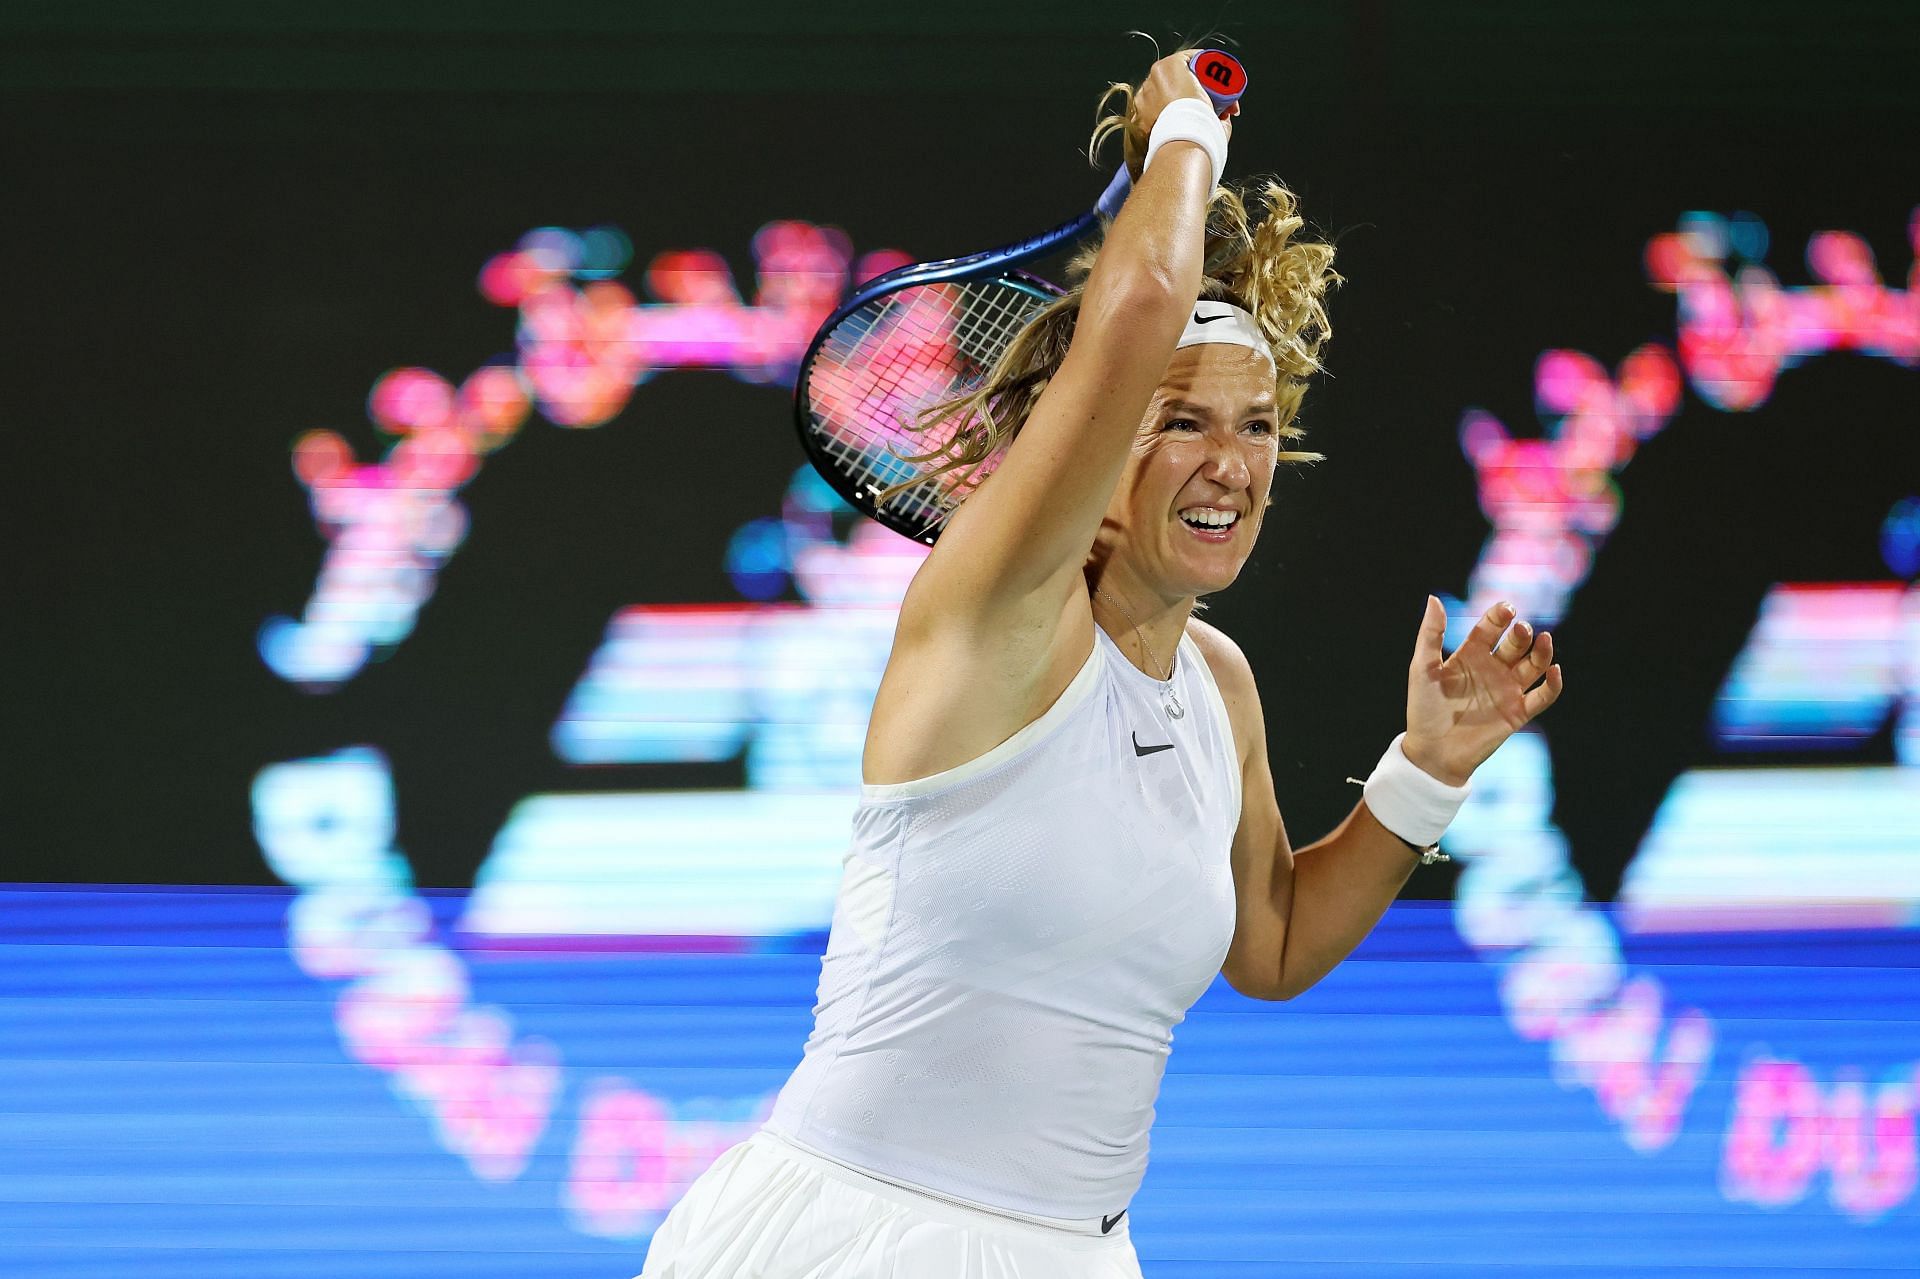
0,887,1920,1279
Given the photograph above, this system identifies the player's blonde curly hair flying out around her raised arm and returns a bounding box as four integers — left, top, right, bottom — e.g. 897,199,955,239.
879,62,1342,501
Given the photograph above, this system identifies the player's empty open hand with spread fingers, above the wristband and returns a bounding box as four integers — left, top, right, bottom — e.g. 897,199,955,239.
1402,595,1563,785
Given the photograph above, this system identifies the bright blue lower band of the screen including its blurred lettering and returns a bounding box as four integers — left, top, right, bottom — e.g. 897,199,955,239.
0,887,1920,1279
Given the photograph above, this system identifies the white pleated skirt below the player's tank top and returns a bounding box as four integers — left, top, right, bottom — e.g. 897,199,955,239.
639,1131,1142,1279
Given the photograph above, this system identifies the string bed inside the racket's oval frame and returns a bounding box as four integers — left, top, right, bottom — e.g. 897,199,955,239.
803,278,1048,536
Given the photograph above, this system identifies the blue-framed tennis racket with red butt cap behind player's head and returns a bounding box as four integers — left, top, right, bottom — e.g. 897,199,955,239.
793,48,1246,545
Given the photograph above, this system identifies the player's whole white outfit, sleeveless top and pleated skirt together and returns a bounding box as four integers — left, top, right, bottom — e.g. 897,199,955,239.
643,626,1240,1279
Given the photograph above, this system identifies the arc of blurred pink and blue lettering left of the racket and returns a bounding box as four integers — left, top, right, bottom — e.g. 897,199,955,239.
259,221,902,691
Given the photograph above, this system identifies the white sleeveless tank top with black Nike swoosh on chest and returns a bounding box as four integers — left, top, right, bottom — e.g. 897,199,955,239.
766,626,1240,1218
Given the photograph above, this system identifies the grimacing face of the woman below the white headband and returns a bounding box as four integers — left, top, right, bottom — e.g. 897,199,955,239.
1096,342,1279,603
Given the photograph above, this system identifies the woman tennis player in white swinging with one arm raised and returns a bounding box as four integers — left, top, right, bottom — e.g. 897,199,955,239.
645,52,1561,1279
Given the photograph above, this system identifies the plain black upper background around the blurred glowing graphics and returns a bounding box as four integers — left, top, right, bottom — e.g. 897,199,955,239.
0,2,1920,897
